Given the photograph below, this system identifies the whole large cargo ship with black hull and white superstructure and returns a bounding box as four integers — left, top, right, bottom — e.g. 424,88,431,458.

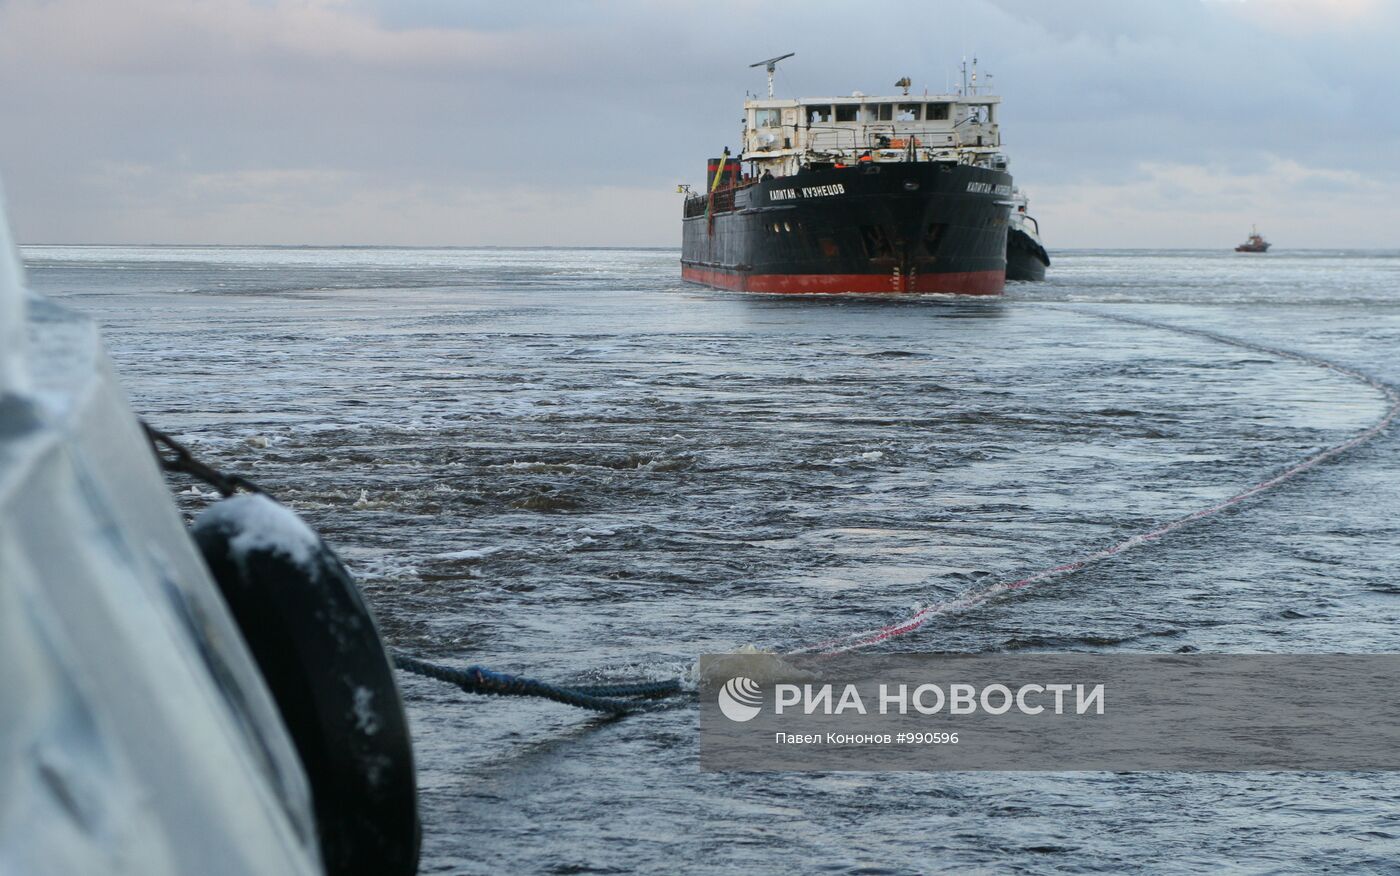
680,55,1012,295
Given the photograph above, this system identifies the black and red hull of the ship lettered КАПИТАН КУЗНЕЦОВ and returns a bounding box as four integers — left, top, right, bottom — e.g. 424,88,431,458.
680,162,1011,295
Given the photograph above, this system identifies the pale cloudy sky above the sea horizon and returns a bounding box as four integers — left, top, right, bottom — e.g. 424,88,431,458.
0,0,1400,248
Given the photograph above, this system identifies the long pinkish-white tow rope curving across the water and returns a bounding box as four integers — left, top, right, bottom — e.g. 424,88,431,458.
788,308,1400,655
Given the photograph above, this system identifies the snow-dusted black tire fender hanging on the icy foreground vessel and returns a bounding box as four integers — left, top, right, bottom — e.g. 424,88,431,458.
190,494,421,876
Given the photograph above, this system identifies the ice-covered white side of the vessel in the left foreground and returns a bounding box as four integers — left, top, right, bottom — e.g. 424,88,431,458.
0,190,321,876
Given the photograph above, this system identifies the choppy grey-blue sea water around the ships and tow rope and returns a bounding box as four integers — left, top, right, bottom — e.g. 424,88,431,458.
25,248,1400,873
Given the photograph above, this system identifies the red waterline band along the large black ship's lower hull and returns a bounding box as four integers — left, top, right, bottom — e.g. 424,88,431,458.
680,264,1007,295
